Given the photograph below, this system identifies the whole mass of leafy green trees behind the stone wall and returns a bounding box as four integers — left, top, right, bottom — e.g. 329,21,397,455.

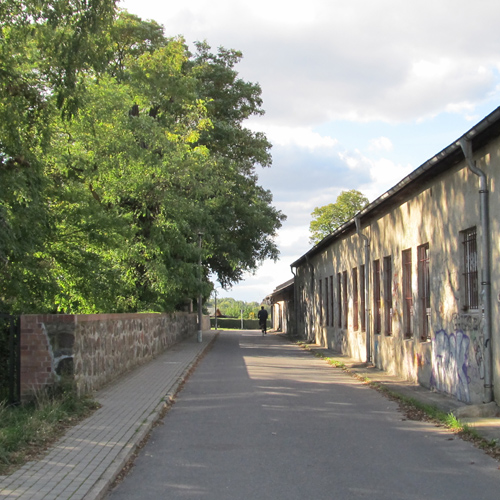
0,0,285,313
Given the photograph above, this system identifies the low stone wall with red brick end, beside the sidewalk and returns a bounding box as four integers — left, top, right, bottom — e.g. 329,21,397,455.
21,313,203,399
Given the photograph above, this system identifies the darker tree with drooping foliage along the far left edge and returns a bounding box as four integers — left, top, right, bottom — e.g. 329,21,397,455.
0,0,115,311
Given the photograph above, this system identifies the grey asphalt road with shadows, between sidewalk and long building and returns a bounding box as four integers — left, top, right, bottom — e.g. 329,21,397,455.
107,331,500,500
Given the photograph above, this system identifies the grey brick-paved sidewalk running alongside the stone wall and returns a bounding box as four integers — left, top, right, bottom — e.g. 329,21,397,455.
0,331,217,500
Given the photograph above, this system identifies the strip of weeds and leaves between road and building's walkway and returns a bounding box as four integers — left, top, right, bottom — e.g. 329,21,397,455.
297,341,500,460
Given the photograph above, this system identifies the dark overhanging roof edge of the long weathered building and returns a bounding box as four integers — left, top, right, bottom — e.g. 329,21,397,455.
291,107,500,267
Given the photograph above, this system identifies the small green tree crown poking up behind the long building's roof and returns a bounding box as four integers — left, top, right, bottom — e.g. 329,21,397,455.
309,189,369,244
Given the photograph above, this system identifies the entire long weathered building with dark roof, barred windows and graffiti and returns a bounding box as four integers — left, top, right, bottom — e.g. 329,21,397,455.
292,108,500,404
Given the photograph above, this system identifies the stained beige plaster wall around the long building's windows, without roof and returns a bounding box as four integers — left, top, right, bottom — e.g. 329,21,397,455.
296,135,500,403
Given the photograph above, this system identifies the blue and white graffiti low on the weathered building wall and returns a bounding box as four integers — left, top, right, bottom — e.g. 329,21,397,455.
431,330,470,403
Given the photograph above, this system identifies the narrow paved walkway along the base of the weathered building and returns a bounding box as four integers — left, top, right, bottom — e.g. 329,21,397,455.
296,344,500,446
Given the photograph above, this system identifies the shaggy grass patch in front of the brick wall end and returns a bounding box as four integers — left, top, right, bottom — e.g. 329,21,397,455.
0,382,99,475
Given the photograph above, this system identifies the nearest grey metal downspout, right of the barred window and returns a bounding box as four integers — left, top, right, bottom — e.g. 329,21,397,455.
460,137,493,403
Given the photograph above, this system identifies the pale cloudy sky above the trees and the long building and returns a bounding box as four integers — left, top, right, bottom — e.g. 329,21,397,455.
119,0,500,302
